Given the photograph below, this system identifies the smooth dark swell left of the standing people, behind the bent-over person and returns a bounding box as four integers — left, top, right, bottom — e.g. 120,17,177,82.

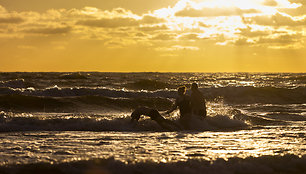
0,94,172,112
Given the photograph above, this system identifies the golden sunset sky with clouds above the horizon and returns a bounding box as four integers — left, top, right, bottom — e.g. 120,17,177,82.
0,0,306,72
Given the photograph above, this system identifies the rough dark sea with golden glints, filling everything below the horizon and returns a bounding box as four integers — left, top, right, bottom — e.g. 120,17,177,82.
0,72,306,174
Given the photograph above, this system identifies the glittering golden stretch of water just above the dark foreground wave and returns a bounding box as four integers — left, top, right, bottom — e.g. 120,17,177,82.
0,127,306,165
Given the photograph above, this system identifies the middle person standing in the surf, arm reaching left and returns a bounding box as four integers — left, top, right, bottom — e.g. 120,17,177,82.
166,86,191,129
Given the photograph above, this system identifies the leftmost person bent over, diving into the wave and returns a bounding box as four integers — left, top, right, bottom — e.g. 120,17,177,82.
131,107,181,130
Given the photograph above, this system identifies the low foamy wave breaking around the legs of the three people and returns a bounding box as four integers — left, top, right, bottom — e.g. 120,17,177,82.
0,112,255,132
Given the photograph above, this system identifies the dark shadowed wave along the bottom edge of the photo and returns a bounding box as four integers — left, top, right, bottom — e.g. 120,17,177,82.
0,155,306,174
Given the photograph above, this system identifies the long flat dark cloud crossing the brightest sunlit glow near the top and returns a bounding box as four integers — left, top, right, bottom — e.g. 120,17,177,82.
175,7,259,17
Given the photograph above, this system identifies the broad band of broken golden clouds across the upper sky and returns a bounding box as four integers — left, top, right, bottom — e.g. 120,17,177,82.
0,0,306,50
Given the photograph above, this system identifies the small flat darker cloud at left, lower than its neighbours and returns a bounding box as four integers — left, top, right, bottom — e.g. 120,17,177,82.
23,27,72,35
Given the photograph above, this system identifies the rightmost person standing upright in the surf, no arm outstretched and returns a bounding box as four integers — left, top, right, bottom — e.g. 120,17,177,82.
190,83,207,119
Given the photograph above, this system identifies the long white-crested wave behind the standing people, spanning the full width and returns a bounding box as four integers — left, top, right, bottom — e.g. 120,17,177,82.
0,86,306,104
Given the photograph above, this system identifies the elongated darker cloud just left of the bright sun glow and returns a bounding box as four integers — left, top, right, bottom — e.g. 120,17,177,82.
76,18,139,28
